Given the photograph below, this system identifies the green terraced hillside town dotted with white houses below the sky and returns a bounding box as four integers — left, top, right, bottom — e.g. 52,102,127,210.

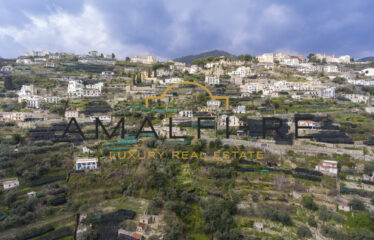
0,50,374,240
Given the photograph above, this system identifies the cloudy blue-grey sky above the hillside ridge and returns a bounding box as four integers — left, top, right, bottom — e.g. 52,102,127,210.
0,0,374,59
